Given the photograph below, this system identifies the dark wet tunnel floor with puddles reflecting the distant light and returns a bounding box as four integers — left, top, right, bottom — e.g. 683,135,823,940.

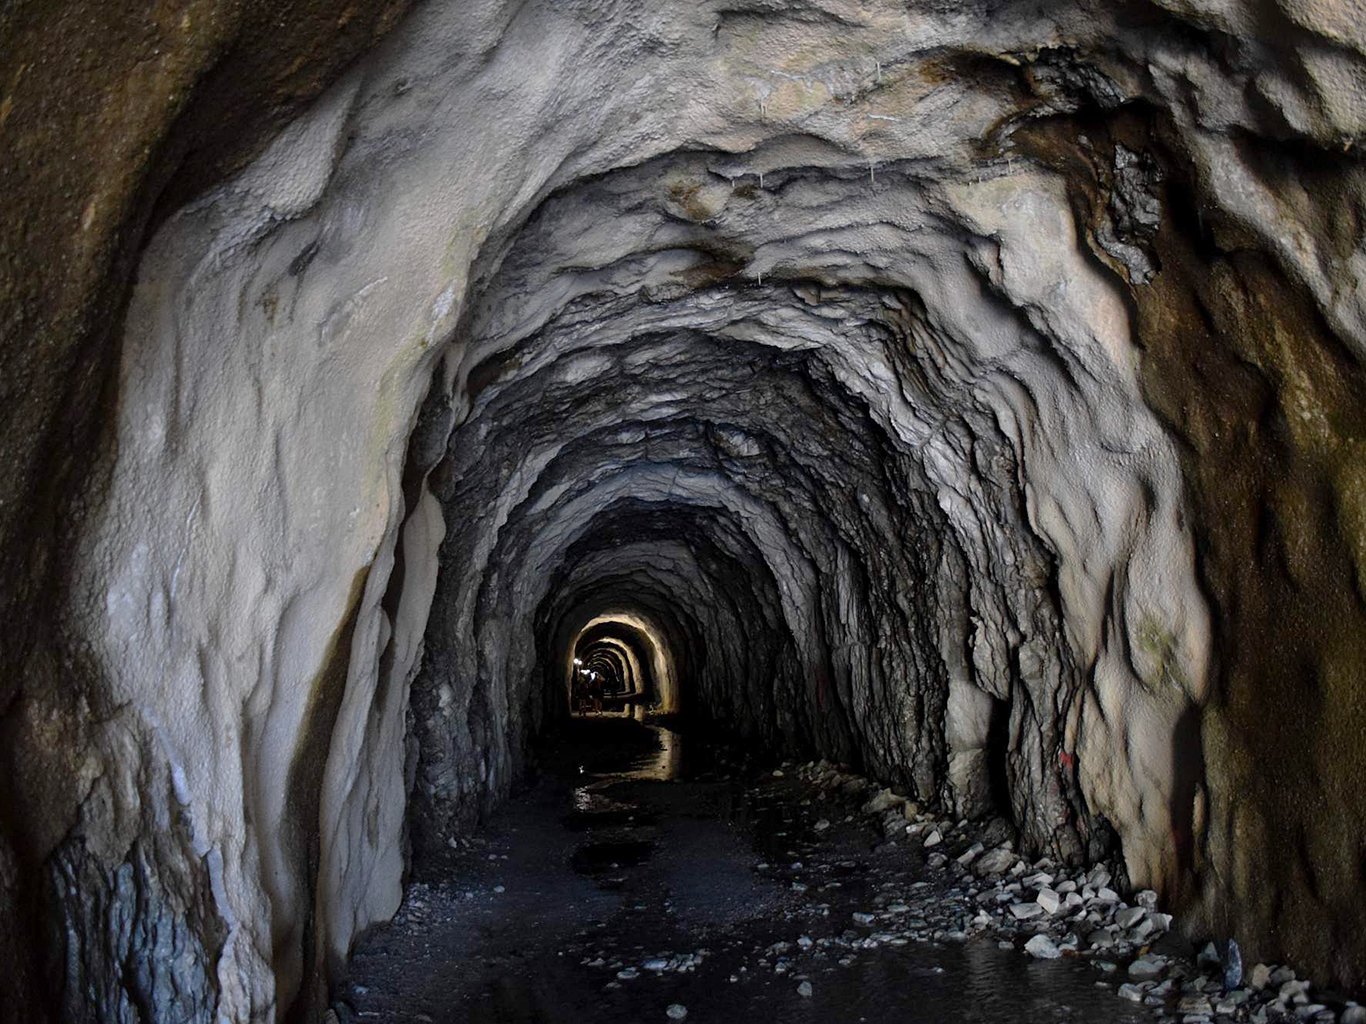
337,717,1153,1024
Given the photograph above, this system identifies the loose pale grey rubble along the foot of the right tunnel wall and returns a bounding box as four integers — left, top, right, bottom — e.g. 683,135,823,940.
784,760,1366,1024
